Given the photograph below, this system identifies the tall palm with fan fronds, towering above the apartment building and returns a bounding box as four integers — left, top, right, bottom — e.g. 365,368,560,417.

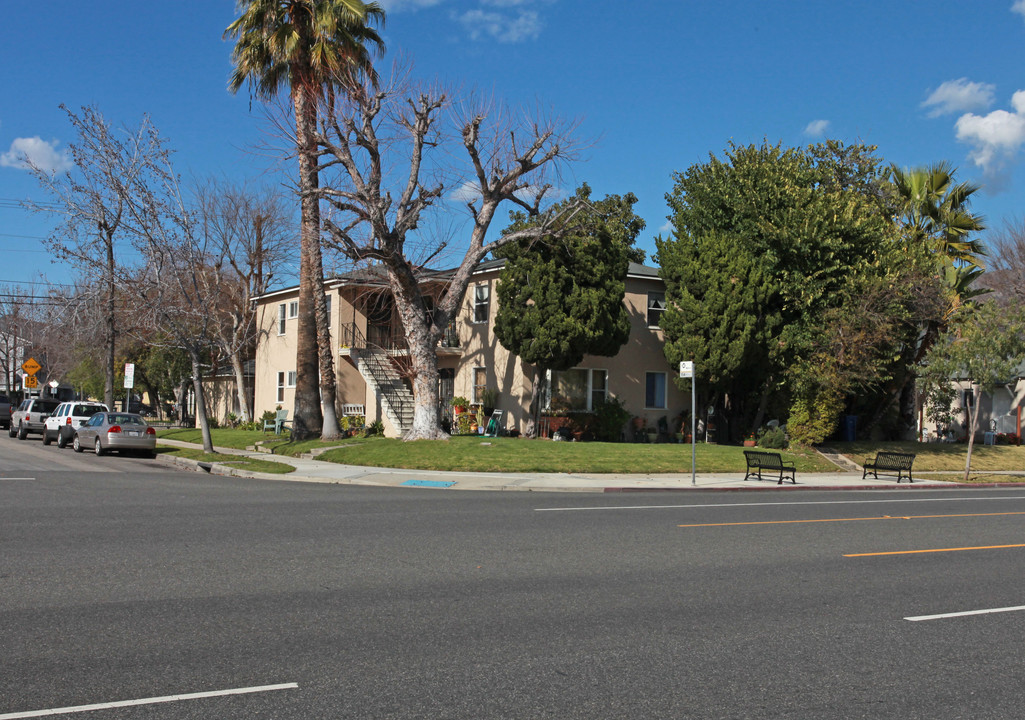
224,0,384,439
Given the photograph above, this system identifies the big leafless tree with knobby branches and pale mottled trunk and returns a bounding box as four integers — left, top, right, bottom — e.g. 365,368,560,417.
318,75,576,440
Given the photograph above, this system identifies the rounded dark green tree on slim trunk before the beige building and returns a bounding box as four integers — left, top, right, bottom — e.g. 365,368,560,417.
495,185,645,436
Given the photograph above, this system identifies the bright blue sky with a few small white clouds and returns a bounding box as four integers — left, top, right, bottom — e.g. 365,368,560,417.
0,0,1025,291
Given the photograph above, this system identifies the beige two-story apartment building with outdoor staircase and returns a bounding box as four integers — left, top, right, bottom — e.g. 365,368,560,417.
254,261,690,436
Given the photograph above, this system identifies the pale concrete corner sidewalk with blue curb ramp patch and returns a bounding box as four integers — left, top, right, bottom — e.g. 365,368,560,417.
158,440,965,492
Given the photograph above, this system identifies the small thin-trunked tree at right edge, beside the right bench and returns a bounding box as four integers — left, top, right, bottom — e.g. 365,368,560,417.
924,303,1025,482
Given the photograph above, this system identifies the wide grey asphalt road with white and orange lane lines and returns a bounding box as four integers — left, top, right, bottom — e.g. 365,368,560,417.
0,436,1025,720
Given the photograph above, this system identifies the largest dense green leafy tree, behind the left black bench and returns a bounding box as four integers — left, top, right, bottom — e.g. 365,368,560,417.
657,142,906,438
